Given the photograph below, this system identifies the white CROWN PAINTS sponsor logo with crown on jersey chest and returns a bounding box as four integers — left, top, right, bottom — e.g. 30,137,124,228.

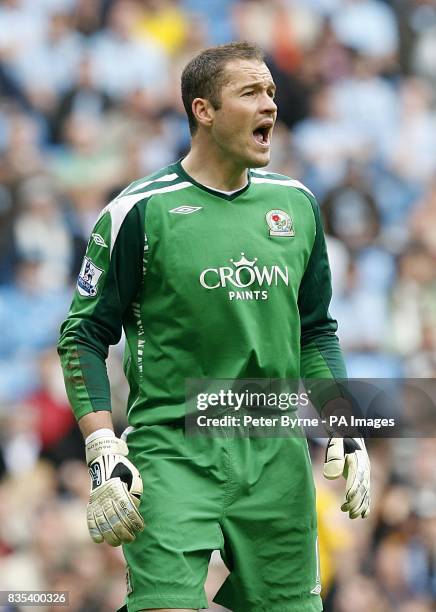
199,253,289,301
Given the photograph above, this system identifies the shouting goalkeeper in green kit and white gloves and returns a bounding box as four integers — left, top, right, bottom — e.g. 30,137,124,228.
59,43,369,612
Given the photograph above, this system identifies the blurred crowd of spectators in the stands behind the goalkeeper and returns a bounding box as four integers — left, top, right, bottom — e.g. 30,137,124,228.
0,0,436,612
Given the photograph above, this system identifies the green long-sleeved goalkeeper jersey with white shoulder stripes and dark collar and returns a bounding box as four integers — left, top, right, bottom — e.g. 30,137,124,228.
58,162,345,426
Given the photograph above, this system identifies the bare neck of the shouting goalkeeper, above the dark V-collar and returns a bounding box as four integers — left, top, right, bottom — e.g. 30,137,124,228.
182,136,248,191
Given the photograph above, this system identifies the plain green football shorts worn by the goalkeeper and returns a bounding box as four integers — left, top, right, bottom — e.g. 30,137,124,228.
117,425,322,612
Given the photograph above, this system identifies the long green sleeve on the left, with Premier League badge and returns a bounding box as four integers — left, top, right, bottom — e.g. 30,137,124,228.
58,205,145,419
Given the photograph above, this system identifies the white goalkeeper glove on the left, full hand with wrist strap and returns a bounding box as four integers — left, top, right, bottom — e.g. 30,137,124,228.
86,430,144,546
